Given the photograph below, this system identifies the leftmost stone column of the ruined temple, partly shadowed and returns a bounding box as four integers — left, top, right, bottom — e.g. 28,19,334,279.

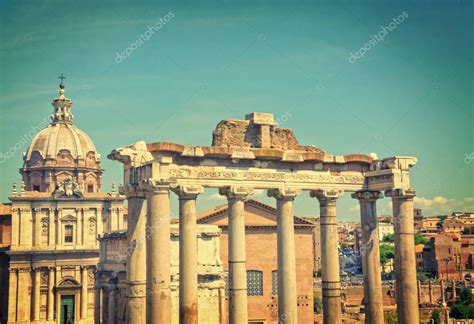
121,185,150,324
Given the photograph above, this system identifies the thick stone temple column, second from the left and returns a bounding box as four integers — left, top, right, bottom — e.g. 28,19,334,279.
146,180,171,324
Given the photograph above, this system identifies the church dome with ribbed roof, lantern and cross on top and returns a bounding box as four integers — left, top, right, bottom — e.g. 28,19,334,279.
20,76,102,193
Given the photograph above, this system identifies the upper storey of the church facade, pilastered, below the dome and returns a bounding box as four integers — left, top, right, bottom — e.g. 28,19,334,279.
10,193,127,251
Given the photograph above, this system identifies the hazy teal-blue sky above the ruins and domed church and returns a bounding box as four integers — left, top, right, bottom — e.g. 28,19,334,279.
0,1,474,220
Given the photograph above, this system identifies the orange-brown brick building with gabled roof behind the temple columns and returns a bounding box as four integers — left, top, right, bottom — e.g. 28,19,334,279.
197,199,314,323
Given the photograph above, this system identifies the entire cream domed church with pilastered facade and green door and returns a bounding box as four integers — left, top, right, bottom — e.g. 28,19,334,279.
0,82,127,323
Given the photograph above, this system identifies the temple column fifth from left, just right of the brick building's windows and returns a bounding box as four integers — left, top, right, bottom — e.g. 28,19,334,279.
268,189,301,324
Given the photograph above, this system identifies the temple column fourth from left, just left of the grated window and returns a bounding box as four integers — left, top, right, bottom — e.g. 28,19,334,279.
219,187,252,324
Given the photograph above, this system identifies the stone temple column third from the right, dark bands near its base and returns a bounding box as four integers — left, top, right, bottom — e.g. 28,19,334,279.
311,190,342,324
